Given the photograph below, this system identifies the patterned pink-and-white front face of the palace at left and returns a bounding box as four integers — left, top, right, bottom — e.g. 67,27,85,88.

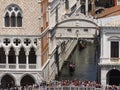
0,0,43,88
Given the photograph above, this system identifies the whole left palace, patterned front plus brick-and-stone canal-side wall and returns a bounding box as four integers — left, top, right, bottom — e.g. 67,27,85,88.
0,0,80,88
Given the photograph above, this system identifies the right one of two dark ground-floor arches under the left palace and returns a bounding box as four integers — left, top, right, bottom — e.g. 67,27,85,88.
20,75,35,86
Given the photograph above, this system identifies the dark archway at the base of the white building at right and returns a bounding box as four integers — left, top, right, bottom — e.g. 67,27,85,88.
107,69,120,85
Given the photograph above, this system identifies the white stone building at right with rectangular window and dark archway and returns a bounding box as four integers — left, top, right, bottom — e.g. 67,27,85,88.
99,16,120,85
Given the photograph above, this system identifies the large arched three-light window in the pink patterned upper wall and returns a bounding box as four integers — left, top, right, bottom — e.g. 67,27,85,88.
4,4,22,27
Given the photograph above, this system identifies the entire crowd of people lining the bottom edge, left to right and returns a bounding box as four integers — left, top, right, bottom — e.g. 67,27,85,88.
0,79,120,90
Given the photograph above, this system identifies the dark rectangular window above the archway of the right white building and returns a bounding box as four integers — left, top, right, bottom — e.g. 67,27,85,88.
111,41,119,58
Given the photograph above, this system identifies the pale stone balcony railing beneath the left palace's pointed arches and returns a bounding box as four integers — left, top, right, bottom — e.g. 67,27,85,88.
0,63,37,69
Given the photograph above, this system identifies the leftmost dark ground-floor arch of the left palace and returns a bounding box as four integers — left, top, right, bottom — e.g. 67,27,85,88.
1,75,15,88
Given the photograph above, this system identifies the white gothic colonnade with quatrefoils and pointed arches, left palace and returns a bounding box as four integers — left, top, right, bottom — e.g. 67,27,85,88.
0,38,40,69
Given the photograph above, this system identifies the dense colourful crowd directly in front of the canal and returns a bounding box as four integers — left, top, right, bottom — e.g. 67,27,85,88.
40,79,101,88
